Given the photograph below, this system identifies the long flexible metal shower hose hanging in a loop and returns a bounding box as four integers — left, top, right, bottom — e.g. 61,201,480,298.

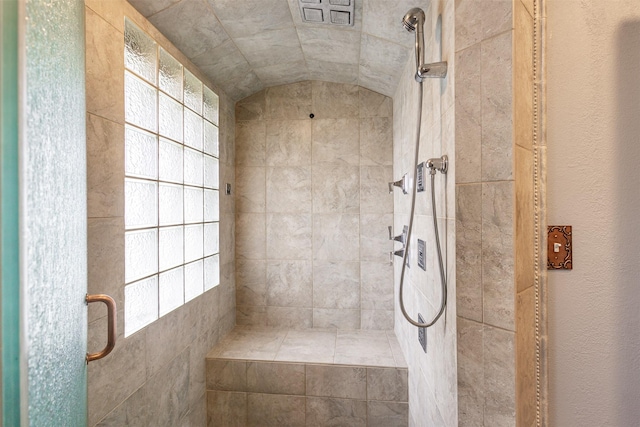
398,82,447,328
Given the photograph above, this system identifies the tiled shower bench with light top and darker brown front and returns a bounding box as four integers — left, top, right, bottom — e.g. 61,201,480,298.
207,326,409,427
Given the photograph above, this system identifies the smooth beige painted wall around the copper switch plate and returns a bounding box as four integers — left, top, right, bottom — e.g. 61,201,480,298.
546,0,640,426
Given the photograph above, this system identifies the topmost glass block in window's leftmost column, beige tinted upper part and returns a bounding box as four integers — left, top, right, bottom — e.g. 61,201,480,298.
124,18,157,84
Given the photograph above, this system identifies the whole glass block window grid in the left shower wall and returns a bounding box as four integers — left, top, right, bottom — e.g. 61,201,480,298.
124,19,220,336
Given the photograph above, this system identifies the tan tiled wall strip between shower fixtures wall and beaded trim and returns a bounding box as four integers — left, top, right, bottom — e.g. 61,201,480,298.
455,0,536,426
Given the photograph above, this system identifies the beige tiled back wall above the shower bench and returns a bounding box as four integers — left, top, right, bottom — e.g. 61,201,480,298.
235,81,393,329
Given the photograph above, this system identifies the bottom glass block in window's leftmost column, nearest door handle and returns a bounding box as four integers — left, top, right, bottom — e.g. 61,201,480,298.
124,276,158,337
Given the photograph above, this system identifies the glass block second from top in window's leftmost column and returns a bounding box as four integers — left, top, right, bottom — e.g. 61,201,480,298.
124,71,158,132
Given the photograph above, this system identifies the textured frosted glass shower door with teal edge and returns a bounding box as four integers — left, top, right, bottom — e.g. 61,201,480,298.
1,0,87,426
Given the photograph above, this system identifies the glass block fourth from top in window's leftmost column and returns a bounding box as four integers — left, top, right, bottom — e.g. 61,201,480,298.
124,178,158,229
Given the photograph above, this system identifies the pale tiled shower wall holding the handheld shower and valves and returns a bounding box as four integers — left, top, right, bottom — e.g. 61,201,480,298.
393,0,458,427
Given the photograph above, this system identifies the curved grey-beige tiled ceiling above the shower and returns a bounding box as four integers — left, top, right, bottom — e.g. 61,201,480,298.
129,0,422,100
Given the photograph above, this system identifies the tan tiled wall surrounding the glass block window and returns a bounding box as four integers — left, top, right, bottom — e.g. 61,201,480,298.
85,0,235,426
